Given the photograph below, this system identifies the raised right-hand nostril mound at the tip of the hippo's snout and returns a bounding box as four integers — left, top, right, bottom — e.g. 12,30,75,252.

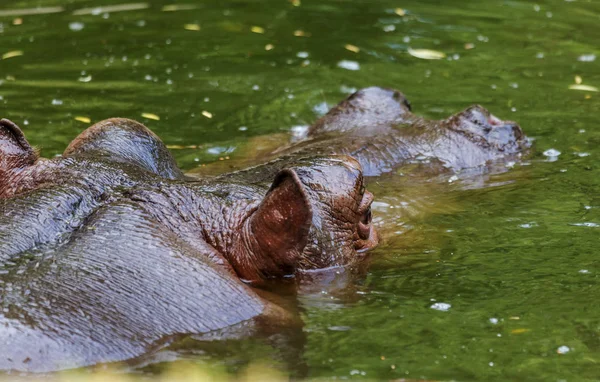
444,105,530,154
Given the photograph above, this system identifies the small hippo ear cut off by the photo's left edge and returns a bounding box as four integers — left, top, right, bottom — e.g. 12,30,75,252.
0,119,37,171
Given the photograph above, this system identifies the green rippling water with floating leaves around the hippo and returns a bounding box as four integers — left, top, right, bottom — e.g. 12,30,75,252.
0,0,600,381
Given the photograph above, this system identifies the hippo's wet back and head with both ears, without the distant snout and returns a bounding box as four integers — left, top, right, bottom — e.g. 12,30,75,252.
0,119,378,372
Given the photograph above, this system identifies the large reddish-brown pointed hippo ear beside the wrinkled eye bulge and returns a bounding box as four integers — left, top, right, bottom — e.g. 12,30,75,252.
235,169,312,281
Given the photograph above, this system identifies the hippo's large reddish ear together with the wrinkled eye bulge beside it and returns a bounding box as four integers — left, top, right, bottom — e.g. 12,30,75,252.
227,155,378,282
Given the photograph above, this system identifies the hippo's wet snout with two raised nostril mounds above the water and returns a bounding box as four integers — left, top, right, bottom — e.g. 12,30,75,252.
193,87,531,176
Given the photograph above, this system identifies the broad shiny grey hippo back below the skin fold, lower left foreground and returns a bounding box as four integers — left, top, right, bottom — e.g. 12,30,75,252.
0,200,265,372
